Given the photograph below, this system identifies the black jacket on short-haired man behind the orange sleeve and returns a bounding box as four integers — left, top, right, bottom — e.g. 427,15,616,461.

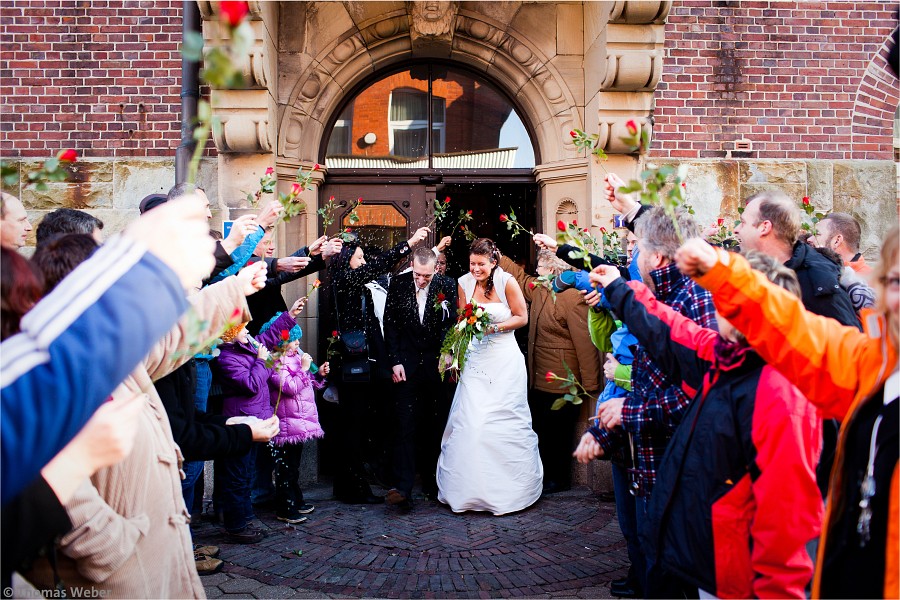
784,242,862,329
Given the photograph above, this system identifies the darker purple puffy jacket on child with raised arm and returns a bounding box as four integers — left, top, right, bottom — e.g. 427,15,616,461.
214,312,297,419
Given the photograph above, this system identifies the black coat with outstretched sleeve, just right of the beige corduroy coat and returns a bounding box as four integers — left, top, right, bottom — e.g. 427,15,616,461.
153,360,253,461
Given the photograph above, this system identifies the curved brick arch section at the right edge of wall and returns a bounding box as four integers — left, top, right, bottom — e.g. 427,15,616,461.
847,32,900,159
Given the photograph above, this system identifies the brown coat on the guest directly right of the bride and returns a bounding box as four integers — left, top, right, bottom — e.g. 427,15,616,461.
500,256,603,395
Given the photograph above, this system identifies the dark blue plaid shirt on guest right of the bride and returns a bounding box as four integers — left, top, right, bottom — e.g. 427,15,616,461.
591,263,717,496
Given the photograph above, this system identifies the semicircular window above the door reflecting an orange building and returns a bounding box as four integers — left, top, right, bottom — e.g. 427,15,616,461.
325,65,535,169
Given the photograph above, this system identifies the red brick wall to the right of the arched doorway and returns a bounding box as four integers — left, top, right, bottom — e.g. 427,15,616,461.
651,0,900,160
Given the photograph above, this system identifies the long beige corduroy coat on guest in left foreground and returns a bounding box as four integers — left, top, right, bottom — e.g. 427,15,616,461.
25,277,250,598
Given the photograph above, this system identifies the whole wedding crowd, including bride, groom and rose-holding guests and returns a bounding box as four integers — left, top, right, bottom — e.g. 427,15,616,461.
0,168,900,597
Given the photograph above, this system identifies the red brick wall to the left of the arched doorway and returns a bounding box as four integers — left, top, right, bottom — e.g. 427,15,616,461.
0,0,181,157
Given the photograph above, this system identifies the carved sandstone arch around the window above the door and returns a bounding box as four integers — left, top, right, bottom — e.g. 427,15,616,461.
277,9,583,163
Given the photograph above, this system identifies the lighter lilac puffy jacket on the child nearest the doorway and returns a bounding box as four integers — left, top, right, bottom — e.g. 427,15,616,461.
269,352,325,446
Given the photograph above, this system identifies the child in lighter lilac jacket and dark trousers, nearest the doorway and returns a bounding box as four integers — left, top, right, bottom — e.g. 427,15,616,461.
260,315,329,523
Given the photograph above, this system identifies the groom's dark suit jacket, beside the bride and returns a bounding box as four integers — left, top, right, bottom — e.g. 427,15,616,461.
384,271,456,378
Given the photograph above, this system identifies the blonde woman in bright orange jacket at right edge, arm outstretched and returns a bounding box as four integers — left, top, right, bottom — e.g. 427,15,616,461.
675,226,900,598
